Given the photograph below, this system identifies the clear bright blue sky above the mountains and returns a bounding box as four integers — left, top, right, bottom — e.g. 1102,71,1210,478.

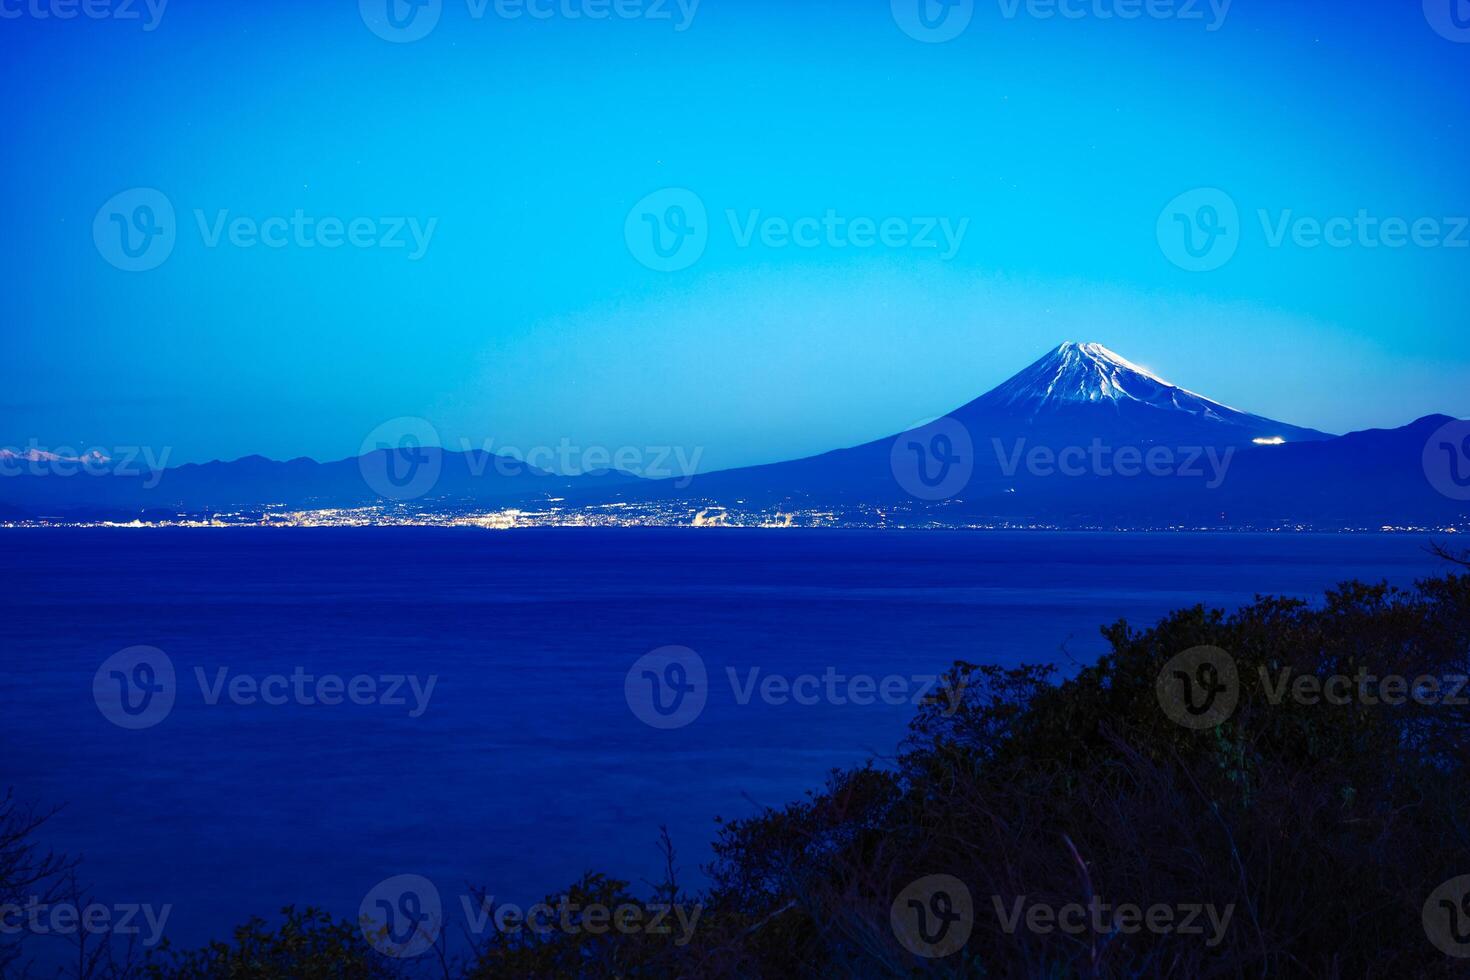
0,0,1470,469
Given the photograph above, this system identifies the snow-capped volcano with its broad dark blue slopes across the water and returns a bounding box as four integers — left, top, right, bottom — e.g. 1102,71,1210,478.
602,342,1470,527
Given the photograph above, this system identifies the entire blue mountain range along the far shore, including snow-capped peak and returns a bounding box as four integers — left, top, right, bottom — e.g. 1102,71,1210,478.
0,342,1470,527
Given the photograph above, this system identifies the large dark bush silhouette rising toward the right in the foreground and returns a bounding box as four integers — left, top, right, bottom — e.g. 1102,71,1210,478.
682,576,1470,977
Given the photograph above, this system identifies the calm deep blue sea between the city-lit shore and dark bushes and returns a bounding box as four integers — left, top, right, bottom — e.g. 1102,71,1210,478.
0,529,1439,945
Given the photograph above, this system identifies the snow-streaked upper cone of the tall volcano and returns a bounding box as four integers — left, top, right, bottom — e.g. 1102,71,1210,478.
961,341,1326,442
